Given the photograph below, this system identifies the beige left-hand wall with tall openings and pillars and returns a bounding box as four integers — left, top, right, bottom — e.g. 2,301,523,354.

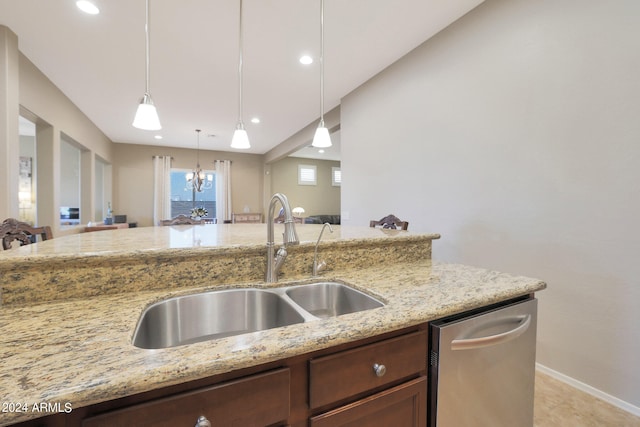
0,31,112,236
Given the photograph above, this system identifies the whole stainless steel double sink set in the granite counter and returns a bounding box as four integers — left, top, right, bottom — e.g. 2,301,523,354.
133,282,384,349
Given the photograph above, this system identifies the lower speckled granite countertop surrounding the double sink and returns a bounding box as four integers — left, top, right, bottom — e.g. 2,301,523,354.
0,226,546,426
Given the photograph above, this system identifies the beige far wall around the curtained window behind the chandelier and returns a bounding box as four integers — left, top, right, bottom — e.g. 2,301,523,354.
113,144,264,227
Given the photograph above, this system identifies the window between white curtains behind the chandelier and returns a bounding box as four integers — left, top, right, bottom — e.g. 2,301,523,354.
171,169,216,218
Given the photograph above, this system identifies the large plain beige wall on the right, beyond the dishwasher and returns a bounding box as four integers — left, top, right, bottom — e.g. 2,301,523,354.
341,0,640,413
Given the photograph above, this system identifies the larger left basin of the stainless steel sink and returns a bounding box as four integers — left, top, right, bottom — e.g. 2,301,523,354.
133,289,305,349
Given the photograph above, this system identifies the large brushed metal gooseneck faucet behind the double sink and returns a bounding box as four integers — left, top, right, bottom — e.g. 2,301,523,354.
264,193,300,283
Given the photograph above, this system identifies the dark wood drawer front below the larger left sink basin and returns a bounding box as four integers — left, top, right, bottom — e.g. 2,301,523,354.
82,369,290,427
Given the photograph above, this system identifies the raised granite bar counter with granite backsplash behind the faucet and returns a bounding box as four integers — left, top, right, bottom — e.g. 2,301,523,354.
0,224,440,306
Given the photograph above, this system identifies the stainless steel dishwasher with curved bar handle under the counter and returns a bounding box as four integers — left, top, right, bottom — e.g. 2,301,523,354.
428,296,538,427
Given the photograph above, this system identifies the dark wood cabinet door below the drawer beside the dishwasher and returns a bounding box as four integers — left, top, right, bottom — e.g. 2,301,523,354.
310,377,427,427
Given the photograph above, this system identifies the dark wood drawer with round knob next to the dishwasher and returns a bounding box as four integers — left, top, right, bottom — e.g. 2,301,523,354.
309,331,427,408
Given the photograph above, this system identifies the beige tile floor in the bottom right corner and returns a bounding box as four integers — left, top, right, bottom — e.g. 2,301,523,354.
534,371,640,427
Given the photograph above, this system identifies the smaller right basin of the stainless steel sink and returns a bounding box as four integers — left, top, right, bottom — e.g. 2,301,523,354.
285,282,384,319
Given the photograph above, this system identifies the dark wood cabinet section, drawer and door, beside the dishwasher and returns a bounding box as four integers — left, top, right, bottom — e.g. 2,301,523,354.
309,330,428,427
